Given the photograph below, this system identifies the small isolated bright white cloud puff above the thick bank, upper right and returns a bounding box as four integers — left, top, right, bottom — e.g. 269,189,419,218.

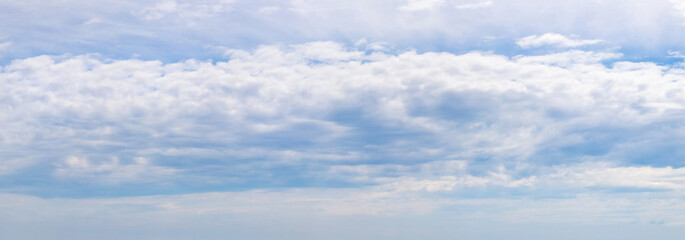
516,33,602,48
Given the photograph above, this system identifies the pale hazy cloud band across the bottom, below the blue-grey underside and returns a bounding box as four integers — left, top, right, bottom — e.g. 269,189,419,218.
5,157,685,239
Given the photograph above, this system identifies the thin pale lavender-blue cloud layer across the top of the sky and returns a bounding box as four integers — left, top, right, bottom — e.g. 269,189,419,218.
0,0,685,64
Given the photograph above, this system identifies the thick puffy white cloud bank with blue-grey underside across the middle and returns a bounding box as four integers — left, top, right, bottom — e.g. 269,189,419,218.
0,42,685,195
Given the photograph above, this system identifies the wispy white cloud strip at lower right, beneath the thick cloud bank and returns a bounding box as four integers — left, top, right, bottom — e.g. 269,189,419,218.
325,161,685,192
